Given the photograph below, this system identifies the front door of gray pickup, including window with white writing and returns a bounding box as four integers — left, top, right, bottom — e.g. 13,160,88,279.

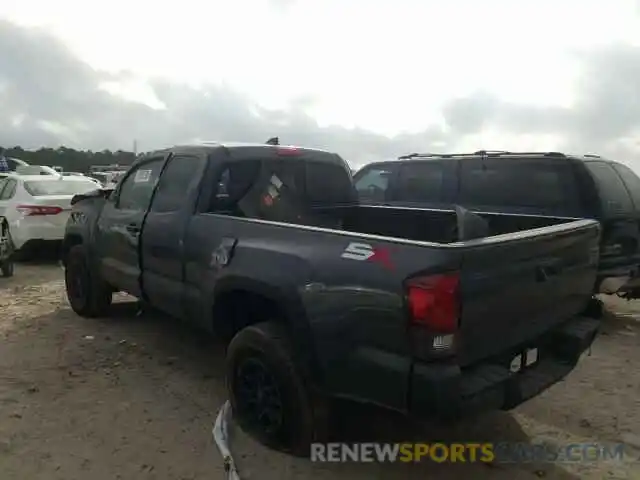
96,157,166,298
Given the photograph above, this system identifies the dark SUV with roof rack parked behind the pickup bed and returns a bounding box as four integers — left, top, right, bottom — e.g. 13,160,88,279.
354,151,640,298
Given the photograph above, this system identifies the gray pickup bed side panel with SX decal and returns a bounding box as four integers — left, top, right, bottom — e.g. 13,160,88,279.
185,214,460,408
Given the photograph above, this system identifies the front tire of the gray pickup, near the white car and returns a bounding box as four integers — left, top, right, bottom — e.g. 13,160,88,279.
64,245,113,318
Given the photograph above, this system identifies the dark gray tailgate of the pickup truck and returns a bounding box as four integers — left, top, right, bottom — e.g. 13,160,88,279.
457,220,600,365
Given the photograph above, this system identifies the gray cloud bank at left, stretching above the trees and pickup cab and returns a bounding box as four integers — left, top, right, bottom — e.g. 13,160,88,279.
0,21,445,164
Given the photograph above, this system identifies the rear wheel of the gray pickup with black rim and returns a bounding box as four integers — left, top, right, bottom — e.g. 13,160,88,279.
226,322,329,456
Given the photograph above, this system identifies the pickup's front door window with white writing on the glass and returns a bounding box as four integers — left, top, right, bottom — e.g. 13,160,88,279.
115,158,164,210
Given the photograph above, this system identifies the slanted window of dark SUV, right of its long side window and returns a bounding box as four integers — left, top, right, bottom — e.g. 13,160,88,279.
585,161,634,216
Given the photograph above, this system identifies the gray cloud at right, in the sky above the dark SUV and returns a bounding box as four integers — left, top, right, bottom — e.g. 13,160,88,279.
443,45,640,162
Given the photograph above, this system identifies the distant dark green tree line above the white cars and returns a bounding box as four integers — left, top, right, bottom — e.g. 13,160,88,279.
4,147,136,173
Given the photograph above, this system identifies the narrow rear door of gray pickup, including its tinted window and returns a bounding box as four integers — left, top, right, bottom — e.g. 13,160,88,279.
140,154,207,318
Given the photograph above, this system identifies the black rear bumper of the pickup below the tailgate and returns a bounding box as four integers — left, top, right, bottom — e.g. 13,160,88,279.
409,318,599,420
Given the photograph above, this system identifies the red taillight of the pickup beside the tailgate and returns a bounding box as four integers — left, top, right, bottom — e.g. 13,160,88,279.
407,273,460,333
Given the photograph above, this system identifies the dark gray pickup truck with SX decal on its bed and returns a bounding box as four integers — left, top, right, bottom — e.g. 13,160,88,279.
63,143,600,455
